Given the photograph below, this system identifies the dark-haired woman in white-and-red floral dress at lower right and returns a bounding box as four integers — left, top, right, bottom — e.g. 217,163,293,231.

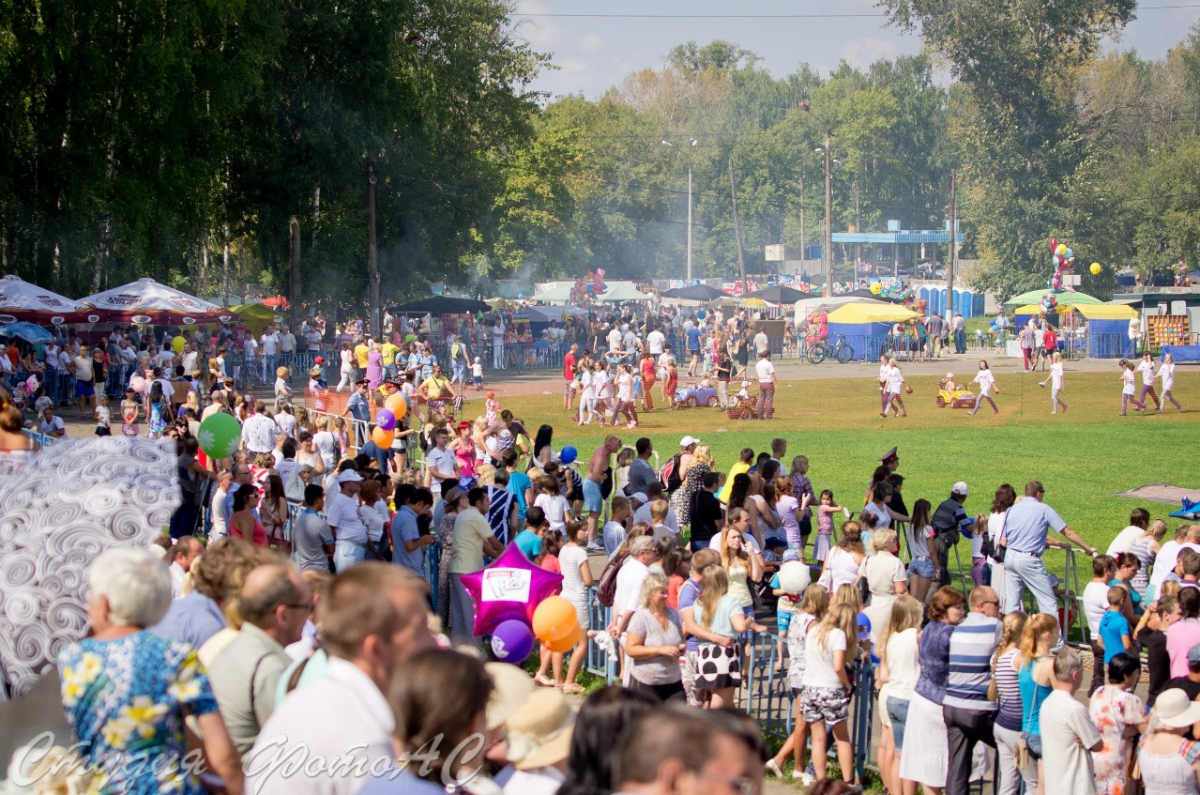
1087,654,1146,795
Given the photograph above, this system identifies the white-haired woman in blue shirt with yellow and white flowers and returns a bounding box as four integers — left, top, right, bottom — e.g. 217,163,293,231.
59,548,242,795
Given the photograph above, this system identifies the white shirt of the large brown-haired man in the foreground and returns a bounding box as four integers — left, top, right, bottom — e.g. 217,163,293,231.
244,657,396,795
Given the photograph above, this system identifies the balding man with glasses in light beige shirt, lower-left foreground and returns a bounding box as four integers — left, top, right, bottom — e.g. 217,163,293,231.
209,563,312,755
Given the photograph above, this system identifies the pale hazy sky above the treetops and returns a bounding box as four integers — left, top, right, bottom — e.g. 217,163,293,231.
514,0,1200,100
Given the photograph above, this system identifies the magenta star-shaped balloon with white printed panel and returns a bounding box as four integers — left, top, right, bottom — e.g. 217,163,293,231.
462,544,563,635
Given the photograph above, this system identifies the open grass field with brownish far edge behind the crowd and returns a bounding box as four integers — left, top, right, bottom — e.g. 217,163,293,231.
487,367,1200,559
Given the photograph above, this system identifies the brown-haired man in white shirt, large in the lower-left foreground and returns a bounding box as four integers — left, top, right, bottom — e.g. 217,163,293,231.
244,562,436,795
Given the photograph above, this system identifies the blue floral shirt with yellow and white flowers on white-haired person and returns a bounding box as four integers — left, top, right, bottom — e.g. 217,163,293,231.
59,630,217,795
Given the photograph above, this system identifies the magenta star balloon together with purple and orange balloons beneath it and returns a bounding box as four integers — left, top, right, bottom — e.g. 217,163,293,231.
462,544,568,664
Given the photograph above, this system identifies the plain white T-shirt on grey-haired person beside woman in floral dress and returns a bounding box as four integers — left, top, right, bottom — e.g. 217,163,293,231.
1042,691,1100,795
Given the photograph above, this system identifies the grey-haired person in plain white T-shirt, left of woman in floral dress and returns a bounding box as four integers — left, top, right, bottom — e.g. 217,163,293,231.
1042,648,1099,795
